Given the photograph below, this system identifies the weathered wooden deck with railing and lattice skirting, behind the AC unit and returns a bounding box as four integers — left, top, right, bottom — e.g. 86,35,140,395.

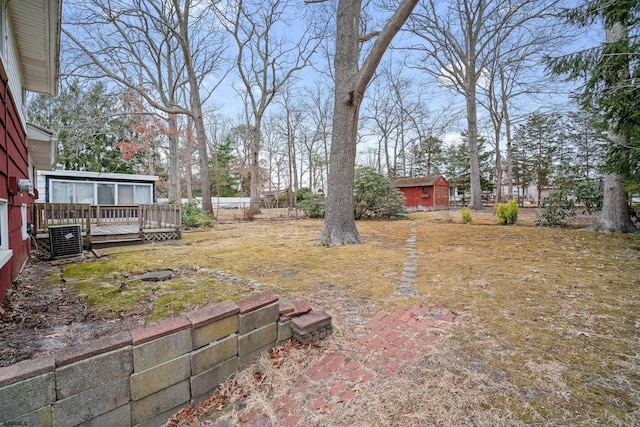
33,203,182,250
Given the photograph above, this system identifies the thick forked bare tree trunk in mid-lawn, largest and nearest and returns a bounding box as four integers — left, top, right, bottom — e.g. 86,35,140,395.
318,0,418,246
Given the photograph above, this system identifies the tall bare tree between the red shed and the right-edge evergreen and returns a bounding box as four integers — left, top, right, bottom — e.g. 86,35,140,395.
411,0,558,209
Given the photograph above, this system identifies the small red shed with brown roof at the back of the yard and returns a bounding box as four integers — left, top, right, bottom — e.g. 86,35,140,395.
392,176,449,211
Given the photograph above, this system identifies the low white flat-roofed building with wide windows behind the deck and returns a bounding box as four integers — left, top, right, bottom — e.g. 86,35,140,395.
36,170,158,206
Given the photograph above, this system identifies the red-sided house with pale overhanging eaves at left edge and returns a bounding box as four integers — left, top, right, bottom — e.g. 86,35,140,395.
0,0,61,301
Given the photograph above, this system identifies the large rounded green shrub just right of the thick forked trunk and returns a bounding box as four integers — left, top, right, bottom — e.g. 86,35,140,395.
353,167,407,219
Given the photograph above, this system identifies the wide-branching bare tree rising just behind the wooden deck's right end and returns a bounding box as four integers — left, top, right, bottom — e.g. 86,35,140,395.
62,0,225,212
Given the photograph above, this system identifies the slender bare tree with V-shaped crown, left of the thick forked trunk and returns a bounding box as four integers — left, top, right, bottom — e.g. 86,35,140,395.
219,0,321,213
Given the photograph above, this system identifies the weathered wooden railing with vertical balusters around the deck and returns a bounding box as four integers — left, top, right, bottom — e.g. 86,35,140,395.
33,203,182,234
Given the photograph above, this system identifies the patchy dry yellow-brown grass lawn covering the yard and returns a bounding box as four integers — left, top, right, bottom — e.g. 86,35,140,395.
51,211,640,426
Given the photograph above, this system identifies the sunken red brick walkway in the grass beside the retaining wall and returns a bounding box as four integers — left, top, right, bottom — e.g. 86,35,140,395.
216,304,456,427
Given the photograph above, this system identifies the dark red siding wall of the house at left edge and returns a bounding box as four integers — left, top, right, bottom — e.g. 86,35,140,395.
0,75,33,301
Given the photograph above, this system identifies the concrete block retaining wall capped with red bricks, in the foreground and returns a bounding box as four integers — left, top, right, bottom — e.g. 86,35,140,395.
0,292,304,427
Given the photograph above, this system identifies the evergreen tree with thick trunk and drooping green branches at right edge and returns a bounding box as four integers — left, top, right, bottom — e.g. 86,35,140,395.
549,0,640,233
